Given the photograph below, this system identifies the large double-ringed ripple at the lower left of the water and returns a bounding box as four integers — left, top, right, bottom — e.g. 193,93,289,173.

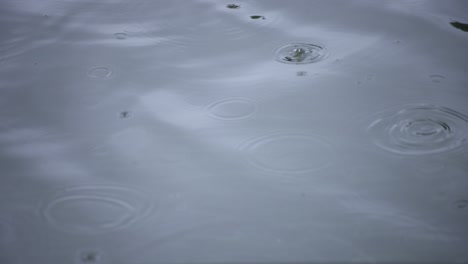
40,185,151,234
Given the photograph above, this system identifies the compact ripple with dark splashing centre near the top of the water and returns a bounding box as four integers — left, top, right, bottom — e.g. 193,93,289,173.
275,43,328,64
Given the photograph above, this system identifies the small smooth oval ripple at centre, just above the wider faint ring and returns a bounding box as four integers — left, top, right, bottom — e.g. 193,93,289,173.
207,97,256,120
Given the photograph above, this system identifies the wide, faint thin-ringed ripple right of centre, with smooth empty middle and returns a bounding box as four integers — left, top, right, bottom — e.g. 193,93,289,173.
240,134,332,173
